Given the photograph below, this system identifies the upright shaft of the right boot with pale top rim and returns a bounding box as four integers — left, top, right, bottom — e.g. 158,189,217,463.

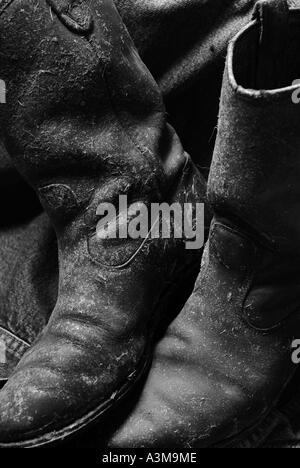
208,1,300,254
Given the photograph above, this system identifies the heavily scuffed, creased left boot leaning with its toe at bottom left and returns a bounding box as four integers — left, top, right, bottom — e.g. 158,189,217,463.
0,0,205,447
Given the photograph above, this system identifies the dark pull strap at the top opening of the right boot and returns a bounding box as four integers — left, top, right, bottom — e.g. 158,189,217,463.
253,0,289,89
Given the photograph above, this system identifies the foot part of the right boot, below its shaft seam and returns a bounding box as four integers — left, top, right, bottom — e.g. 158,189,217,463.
110,221,300,447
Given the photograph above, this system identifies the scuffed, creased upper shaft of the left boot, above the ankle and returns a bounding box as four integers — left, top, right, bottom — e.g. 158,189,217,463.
0,0,186,225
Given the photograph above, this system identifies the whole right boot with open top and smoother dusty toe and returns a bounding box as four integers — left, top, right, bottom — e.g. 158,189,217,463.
110,1,300,448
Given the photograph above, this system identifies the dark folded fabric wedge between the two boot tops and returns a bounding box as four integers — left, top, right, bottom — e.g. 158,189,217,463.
115,0,255,174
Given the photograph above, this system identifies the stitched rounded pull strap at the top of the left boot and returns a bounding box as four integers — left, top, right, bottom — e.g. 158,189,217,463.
47,0,93,36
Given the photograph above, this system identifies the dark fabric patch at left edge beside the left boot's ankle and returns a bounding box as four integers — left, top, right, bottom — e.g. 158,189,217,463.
0,214,58,344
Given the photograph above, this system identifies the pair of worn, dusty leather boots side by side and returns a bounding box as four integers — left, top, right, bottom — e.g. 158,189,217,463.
0,0,300,447
